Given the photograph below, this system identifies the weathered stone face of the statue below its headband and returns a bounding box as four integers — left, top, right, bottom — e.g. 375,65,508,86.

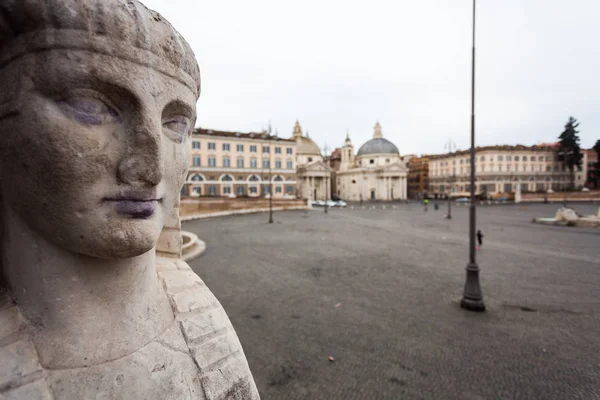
0,50,196,258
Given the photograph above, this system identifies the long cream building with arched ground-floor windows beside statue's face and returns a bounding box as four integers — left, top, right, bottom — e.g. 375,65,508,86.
182,129,297,198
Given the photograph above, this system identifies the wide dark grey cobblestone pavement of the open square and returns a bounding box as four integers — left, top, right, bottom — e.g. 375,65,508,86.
184,203,600,400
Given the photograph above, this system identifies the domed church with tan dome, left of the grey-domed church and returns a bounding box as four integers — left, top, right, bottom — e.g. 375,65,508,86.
290,121,331,200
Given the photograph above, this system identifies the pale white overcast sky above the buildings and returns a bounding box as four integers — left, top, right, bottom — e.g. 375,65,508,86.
142,0,600,154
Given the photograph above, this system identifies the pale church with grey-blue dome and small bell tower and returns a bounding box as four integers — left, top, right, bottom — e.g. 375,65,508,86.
336,123,407,201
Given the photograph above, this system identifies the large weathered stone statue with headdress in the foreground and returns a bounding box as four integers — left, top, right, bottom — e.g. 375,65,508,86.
0,0,259,400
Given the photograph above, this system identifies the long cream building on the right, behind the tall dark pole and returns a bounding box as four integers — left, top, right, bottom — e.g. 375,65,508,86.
429,146,587,197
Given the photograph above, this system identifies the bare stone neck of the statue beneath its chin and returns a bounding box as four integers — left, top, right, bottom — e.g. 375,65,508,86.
2,207,173,368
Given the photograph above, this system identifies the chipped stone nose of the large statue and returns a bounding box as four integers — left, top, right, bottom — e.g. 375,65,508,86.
118,130,164,186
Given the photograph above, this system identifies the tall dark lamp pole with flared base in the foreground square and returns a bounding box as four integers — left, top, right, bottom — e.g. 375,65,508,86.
460,0,485,311
